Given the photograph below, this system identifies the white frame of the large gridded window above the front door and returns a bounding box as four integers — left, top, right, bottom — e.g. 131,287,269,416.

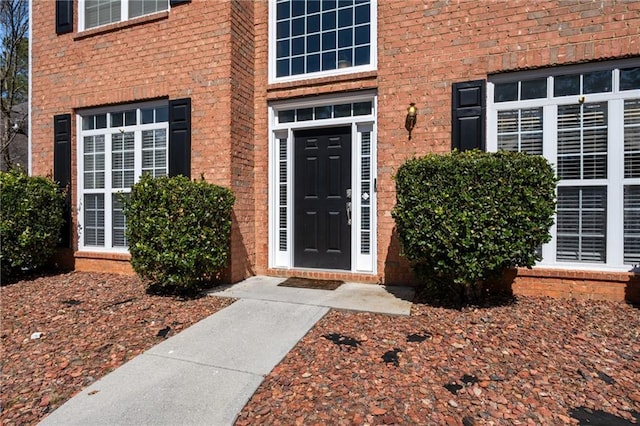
268,0,378,84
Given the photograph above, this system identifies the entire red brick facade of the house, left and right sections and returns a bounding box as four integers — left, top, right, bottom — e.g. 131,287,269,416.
32,0,640,304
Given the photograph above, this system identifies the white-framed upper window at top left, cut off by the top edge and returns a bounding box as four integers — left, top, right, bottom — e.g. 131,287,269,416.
79,0,169,30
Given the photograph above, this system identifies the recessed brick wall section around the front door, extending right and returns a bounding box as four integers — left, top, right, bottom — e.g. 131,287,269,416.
254,0,640,284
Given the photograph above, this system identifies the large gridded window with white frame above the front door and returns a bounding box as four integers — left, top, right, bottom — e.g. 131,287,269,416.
269,0,376,82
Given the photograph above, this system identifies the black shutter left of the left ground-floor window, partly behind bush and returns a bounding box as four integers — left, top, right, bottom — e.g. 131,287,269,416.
53,114,71,247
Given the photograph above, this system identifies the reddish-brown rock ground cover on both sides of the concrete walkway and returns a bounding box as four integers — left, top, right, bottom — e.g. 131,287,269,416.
0,273,640,426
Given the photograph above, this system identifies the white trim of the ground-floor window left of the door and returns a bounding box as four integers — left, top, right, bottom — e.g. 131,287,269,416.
76,102,169,253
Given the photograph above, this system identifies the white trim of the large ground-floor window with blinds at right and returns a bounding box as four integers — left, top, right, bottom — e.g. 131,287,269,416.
487,59,640,272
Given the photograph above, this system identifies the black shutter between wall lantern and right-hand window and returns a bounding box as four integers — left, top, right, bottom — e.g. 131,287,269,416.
451,80,486,151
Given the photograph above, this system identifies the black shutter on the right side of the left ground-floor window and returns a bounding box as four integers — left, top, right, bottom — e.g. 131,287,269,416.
169,98,191,178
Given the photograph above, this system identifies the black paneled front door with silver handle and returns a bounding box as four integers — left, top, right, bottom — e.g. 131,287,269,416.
294,127,351,270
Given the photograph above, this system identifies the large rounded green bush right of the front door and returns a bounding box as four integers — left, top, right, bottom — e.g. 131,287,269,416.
392,151,556,302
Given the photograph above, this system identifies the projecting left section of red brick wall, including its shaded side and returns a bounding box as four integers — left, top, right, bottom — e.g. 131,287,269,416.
32,0,255,280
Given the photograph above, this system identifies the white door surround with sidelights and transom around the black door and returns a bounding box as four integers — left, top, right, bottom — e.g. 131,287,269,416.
268,91,378,275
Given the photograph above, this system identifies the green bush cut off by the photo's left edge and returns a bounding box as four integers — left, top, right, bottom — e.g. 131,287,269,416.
0,169,65,281
